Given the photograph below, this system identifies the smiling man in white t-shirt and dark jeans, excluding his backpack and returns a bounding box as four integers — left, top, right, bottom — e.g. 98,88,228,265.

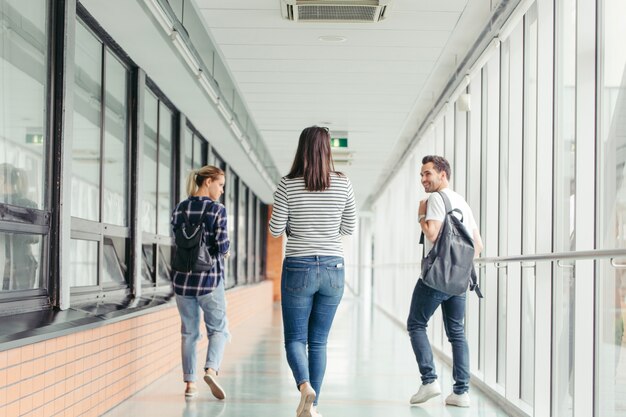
407,155,483,407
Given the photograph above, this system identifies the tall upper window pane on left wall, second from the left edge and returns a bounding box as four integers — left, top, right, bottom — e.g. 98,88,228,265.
72,22,102,221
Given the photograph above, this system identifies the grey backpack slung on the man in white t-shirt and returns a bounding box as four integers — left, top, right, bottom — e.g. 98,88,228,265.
420,191,483,298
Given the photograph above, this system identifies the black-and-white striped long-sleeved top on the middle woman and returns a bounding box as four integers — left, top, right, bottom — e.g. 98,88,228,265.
270,173,356,256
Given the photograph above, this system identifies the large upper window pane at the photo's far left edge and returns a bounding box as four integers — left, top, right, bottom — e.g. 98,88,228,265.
0,0,49,208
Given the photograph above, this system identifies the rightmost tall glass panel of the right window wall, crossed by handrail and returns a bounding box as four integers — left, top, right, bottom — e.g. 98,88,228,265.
595,0,626,417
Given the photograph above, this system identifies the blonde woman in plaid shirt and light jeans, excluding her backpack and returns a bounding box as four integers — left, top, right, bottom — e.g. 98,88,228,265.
172,165,230,400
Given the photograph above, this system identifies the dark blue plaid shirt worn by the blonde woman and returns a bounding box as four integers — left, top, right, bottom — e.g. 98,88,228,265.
171,197,230,296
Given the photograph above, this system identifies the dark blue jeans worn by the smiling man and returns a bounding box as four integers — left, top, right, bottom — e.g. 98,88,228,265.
407,279,470,394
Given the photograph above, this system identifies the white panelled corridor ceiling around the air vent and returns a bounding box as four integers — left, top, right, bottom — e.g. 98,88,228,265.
194,0,491,204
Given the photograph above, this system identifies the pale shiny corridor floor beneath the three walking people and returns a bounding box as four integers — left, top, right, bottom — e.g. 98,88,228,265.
105,297,507,417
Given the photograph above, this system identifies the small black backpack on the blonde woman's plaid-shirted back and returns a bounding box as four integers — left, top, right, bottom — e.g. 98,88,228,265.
172,203,215,273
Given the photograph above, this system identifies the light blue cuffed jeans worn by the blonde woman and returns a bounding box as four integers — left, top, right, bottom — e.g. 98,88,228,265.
176,279,230,382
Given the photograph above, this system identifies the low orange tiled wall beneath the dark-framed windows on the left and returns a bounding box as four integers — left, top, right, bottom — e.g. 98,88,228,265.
0,281,273,417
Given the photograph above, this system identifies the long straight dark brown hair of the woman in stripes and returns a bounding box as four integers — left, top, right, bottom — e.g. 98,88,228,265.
287,126,341,191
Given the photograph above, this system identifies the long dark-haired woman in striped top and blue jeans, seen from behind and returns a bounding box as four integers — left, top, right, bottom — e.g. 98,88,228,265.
270,126,356,417
